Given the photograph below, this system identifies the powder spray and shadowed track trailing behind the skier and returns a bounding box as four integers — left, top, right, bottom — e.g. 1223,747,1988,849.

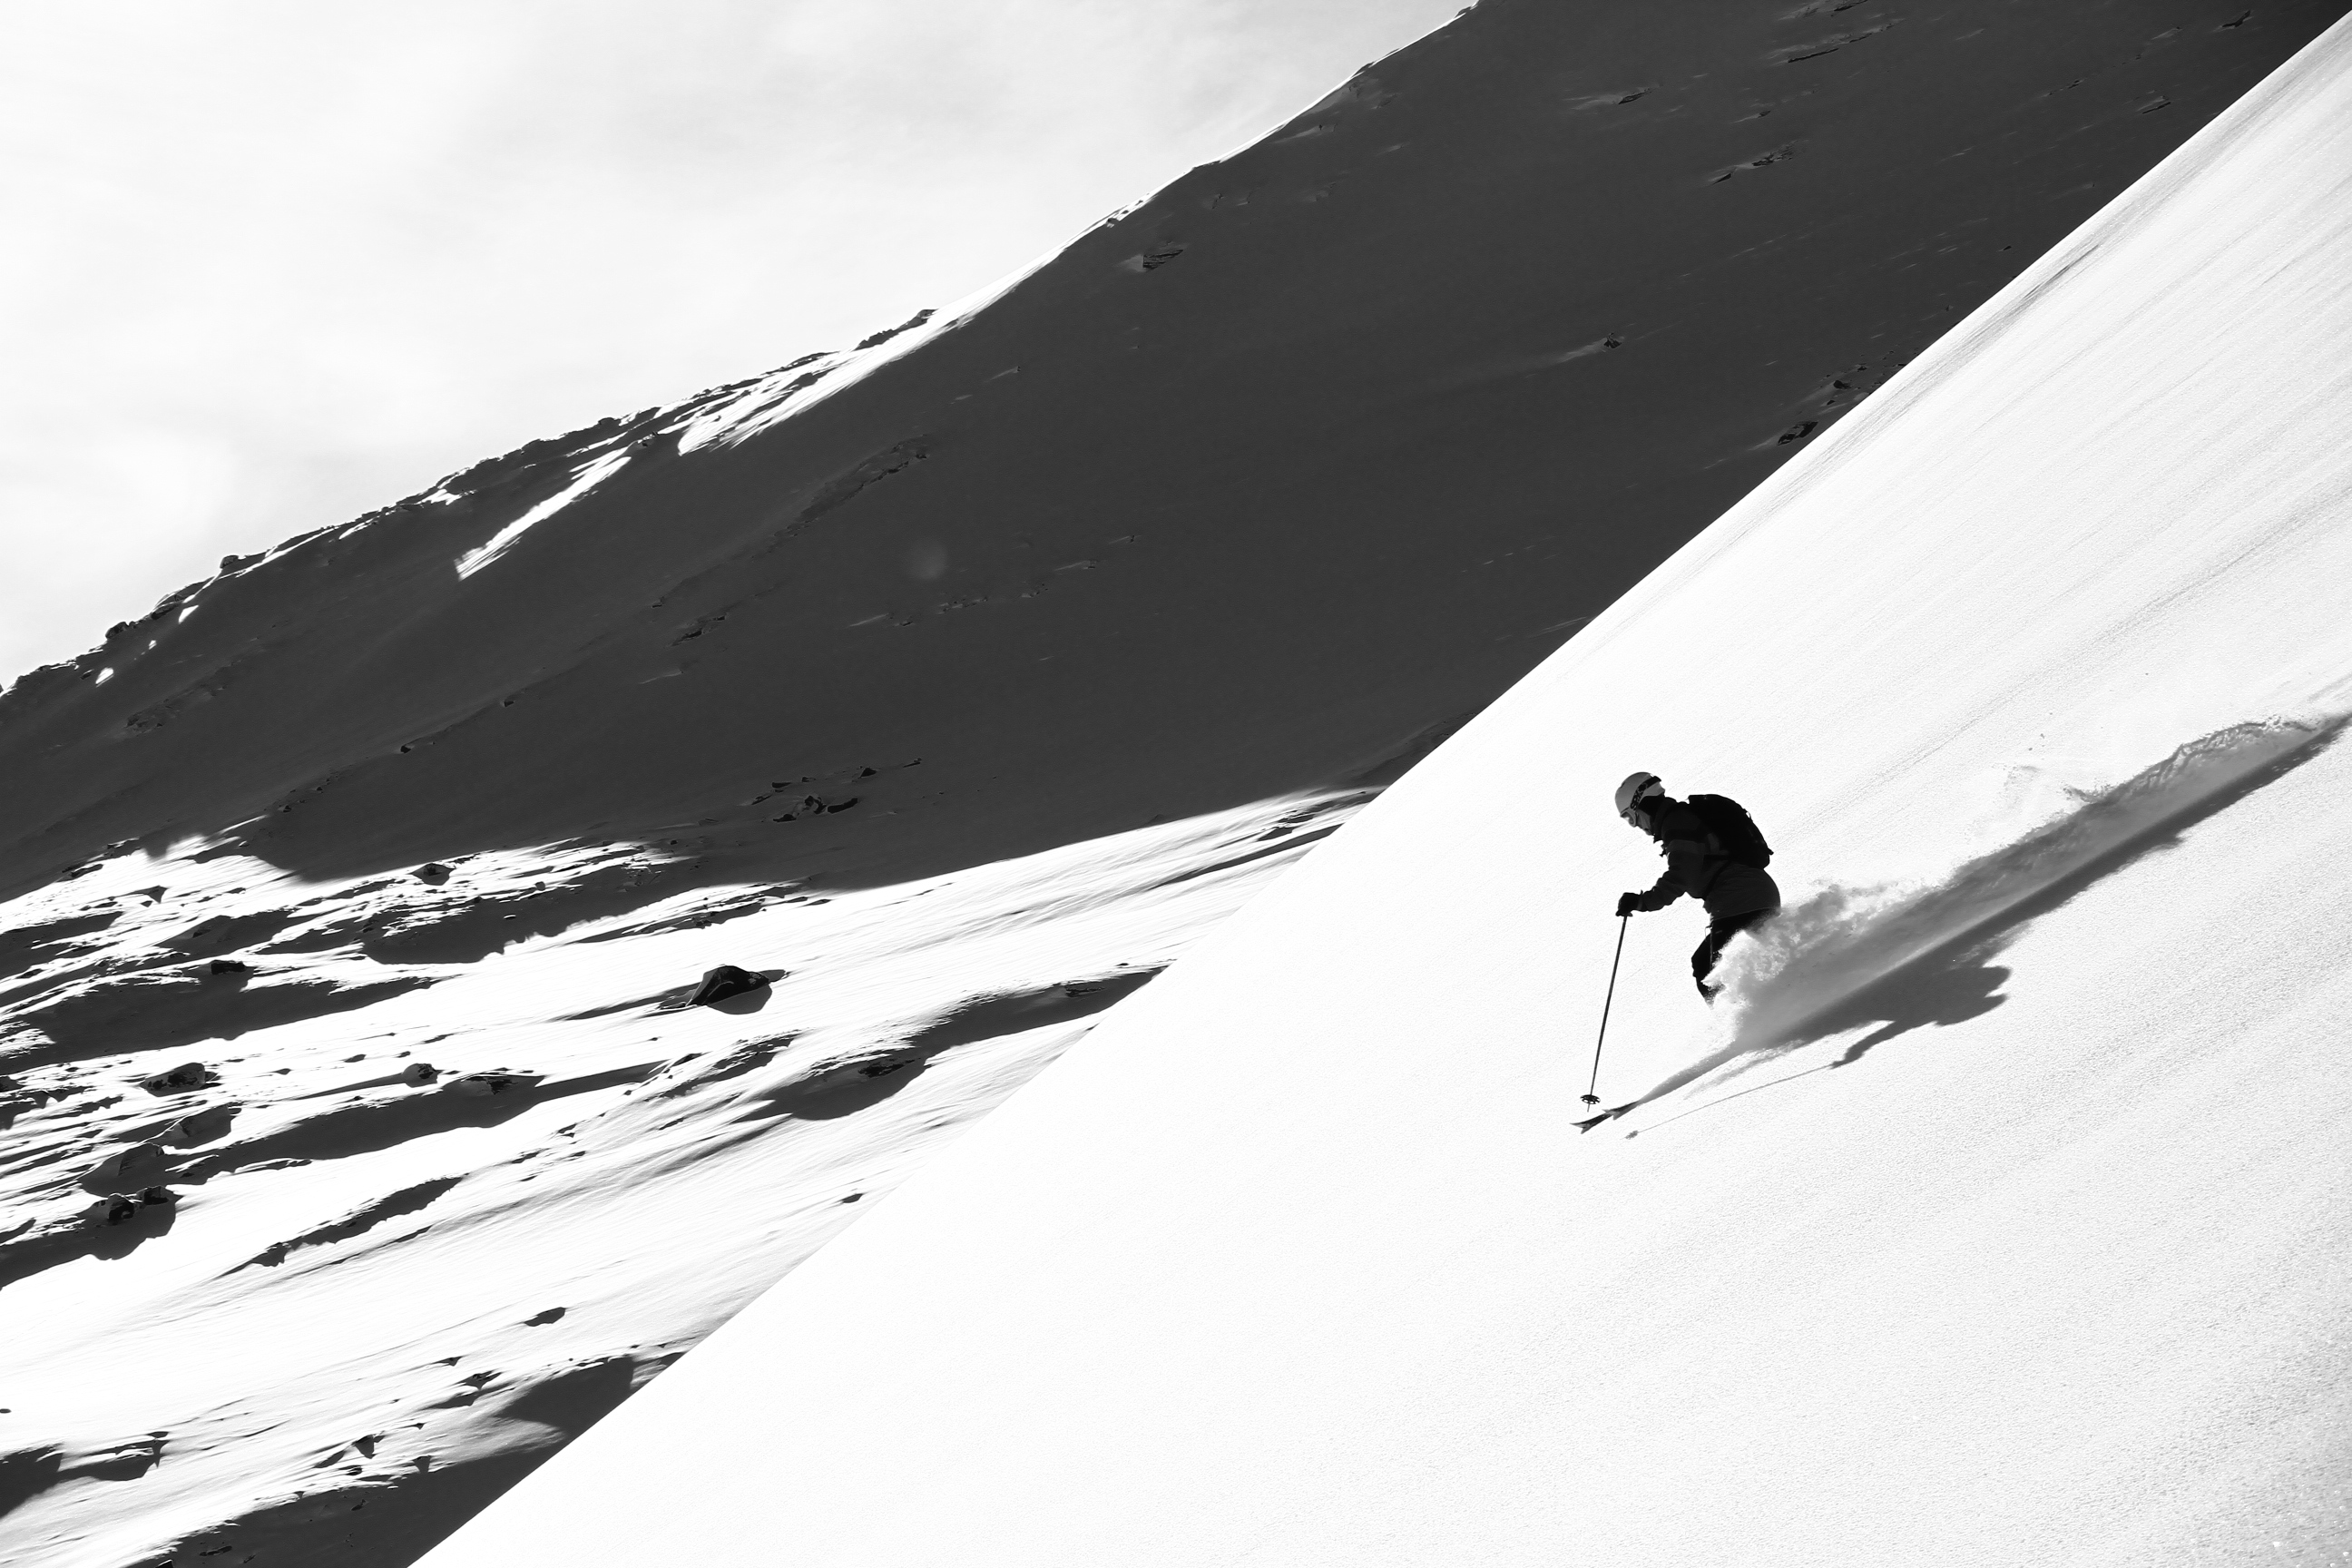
1634,715,2352,1102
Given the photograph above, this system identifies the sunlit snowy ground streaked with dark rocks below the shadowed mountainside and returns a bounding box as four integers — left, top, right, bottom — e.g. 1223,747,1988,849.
0,795,1362,1568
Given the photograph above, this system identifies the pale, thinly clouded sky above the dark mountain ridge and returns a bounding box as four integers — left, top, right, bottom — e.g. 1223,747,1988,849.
0,0,1461,681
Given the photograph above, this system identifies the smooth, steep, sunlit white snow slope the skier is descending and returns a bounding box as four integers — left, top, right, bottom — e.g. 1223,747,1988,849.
428,24,2352,1568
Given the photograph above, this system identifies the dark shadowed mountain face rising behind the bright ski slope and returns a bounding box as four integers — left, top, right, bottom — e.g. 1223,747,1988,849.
0,0,2340,893
